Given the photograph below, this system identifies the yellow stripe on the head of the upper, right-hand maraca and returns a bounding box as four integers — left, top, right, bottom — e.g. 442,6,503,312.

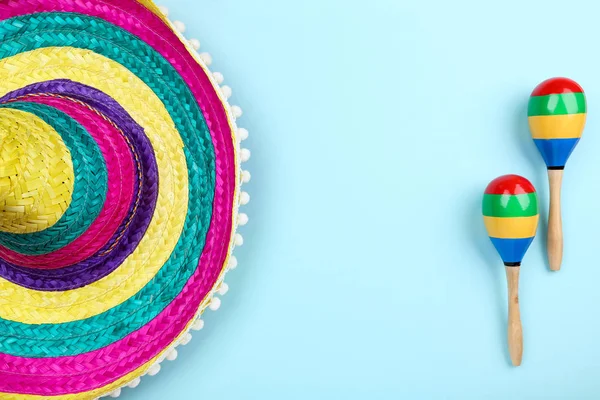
528,113,587,139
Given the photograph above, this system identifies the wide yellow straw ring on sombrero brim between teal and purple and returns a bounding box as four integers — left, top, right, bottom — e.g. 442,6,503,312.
0,47,188,324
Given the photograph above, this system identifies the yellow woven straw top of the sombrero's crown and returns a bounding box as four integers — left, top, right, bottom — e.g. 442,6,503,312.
0,109,75,233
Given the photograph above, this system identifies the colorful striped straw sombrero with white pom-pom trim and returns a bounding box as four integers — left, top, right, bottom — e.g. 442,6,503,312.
0,0,249,400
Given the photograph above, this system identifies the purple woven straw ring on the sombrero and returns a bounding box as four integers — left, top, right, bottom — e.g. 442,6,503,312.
0,79,158,291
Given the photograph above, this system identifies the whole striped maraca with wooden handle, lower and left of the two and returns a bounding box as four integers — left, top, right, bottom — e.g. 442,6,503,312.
482,175,539,366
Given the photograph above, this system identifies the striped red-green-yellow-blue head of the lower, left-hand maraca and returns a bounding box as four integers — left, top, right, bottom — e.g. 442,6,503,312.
482,175,539,266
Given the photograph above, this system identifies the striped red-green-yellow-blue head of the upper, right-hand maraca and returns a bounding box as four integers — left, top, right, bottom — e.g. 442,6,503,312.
527,78,586,169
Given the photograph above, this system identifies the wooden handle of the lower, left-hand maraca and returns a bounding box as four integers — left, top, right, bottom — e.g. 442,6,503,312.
506,267,523,367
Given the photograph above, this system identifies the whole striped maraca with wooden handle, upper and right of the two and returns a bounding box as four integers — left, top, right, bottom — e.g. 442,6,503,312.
527,78,586,271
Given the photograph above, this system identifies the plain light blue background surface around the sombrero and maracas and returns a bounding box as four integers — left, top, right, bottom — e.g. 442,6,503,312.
134,0,600,400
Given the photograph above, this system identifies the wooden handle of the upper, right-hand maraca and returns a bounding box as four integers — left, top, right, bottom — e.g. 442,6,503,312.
547,169,563,271
